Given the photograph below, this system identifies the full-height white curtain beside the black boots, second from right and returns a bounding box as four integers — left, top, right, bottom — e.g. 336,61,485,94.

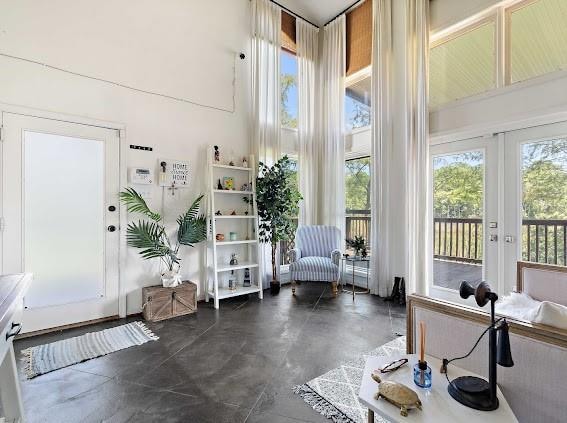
370,0,393,296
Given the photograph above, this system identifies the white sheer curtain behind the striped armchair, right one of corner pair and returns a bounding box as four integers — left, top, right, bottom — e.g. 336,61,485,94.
319,15,346,238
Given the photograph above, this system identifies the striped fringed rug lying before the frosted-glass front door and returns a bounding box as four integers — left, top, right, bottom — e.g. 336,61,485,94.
22,322,159,379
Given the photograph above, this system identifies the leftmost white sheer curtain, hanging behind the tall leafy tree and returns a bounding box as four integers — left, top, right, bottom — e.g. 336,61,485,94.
251,0,281,287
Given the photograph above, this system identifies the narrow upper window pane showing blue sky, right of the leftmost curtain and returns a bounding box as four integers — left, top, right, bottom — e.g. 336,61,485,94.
280,50,298,129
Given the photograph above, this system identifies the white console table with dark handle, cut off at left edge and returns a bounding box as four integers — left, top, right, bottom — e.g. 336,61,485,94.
0,273,32,422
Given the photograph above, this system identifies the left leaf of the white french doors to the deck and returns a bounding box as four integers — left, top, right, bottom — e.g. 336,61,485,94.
429,136,499,305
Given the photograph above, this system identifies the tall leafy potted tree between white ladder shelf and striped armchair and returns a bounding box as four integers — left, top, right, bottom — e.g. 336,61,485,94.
256,156,302,295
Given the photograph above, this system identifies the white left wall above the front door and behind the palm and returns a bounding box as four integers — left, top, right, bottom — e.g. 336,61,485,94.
0,0,250,313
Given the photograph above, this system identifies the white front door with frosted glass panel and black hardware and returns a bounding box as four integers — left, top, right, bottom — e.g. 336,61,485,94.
1,113,119,332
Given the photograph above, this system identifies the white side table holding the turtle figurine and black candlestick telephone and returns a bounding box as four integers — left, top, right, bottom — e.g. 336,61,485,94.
358,354,518,423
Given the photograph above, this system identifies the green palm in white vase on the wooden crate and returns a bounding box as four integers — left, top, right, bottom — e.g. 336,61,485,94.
120,188,207,287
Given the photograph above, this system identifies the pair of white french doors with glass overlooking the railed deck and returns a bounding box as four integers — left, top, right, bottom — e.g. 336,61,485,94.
429,122,567,305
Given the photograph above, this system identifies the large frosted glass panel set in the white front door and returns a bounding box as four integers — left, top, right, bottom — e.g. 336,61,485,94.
23,131,105,308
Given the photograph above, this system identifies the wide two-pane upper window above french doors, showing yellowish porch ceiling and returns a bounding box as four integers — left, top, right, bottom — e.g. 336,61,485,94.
429,0,567,107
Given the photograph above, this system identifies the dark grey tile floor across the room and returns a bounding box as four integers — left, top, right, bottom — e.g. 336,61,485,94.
15,283,405,423
